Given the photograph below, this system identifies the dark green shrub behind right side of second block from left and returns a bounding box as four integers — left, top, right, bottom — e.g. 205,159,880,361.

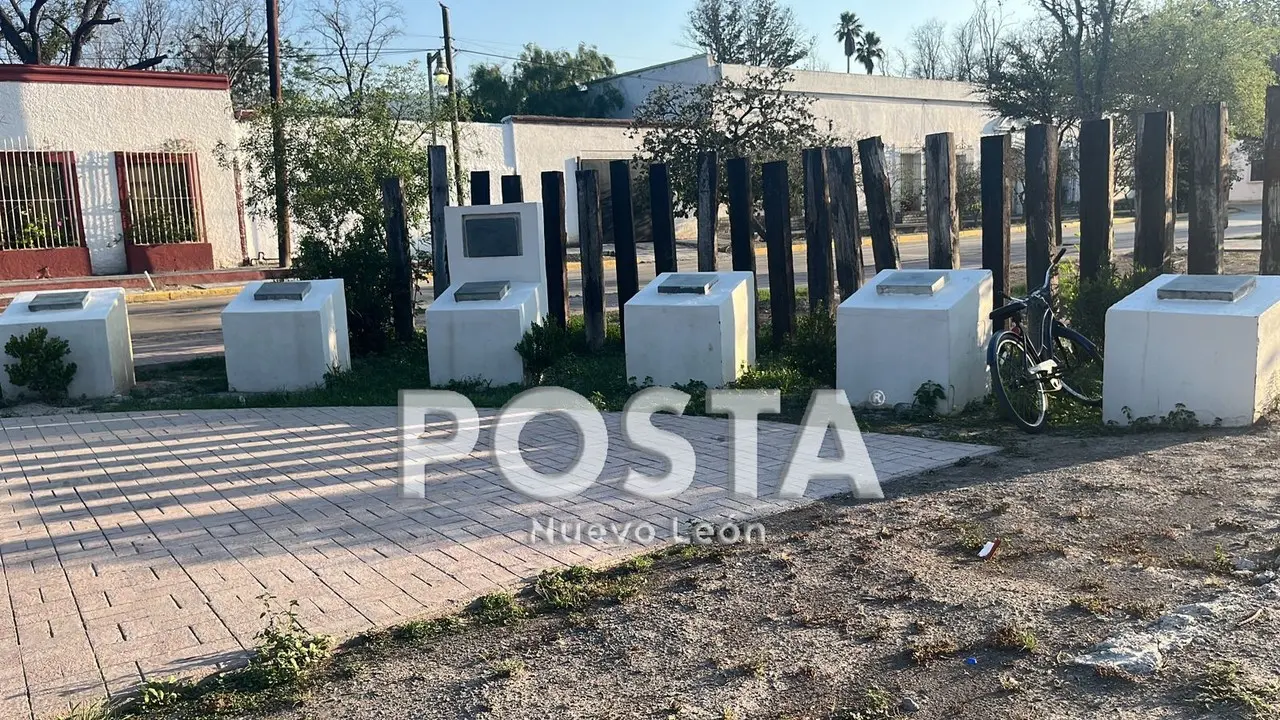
293,223,392,355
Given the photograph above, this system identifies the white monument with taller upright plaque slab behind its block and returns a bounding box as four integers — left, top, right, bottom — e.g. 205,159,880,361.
426,202,547,386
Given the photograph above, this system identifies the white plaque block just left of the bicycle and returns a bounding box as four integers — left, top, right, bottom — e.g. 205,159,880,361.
836,270,992,413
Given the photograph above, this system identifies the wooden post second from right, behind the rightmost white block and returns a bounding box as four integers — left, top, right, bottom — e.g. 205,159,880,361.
1187,102,1231,275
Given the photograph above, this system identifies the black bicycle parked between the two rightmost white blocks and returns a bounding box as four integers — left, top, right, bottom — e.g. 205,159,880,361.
987,247,1102,433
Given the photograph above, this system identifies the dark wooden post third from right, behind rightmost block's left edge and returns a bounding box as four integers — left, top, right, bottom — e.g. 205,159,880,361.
1133,113,1174,270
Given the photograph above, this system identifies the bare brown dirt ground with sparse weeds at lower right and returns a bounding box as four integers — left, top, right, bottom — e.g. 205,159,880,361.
235,424,1280,720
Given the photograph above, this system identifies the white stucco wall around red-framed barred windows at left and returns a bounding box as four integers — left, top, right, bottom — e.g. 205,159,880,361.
0,75,242,274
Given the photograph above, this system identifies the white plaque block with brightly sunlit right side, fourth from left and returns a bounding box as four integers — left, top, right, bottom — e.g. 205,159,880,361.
623,273,755,387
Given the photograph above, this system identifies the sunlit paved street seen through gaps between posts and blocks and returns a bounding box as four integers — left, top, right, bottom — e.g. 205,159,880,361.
129,210,1262,364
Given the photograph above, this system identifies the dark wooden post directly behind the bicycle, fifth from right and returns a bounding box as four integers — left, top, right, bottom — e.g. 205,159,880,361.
1027,124,1057,342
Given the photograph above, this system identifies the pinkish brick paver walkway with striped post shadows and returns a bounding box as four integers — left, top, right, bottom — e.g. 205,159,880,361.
0,407,992,719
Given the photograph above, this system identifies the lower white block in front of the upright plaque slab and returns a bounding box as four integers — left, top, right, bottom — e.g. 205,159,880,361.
426,282,545,386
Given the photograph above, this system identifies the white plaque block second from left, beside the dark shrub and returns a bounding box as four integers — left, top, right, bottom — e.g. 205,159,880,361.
223,279,351,392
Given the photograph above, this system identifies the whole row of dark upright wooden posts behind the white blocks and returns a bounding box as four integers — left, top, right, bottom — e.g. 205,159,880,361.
384,94,1280,348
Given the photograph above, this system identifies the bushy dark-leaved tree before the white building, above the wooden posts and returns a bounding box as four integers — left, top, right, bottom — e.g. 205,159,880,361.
630,68,832,214
